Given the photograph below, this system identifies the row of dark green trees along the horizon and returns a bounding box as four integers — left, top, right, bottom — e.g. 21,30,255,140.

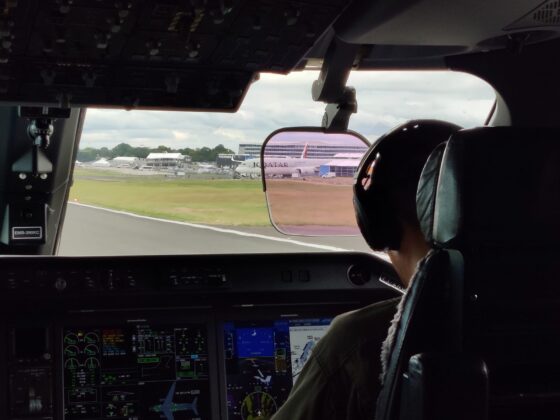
77,143,235,162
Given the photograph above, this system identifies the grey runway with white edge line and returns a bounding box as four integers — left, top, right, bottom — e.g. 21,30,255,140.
58,203,371,256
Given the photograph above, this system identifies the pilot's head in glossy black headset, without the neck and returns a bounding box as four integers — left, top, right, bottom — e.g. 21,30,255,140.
353,120,461,251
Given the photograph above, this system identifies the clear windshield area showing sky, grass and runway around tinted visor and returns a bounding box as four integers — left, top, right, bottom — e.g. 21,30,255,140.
58,71,495,255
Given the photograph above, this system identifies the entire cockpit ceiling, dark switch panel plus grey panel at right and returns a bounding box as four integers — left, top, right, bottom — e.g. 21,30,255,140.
0,0,560,112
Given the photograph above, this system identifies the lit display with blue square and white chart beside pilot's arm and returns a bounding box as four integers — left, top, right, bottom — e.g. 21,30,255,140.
224,318,332,420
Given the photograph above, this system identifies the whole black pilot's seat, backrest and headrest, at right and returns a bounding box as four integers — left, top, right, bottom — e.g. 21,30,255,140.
376,127,560,420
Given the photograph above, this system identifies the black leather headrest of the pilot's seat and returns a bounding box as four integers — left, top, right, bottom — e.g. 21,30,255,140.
417,127,560,249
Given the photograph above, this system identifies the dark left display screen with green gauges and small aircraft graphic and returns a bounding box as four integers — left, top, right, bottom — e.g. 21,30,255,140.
63,323,210,420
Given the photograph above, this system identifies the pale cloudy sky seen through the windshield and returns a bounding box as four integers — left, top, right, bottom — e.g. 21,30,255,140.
80,71,495,152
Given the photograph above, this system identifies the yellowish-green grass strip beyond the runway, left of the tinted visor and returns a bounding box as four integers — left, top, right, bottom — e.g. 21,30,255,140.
70,168,270,226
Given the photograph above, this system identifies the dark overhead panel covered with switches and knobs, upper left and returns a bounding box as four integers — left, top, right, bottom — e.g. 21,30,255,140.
0,0,347,111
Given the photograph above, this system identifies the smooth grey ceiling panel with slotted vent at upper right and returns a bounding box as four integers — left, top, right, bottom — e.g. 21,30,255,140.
335,0,560,64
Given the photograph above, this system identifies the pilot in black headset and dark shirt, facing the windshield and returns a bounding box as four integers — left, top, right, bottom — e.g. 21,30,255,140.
272,120,460,420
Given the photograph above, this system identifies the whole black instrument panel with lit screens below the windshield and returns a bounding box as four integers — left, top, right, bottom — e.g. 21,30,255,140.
0,254,402,420
